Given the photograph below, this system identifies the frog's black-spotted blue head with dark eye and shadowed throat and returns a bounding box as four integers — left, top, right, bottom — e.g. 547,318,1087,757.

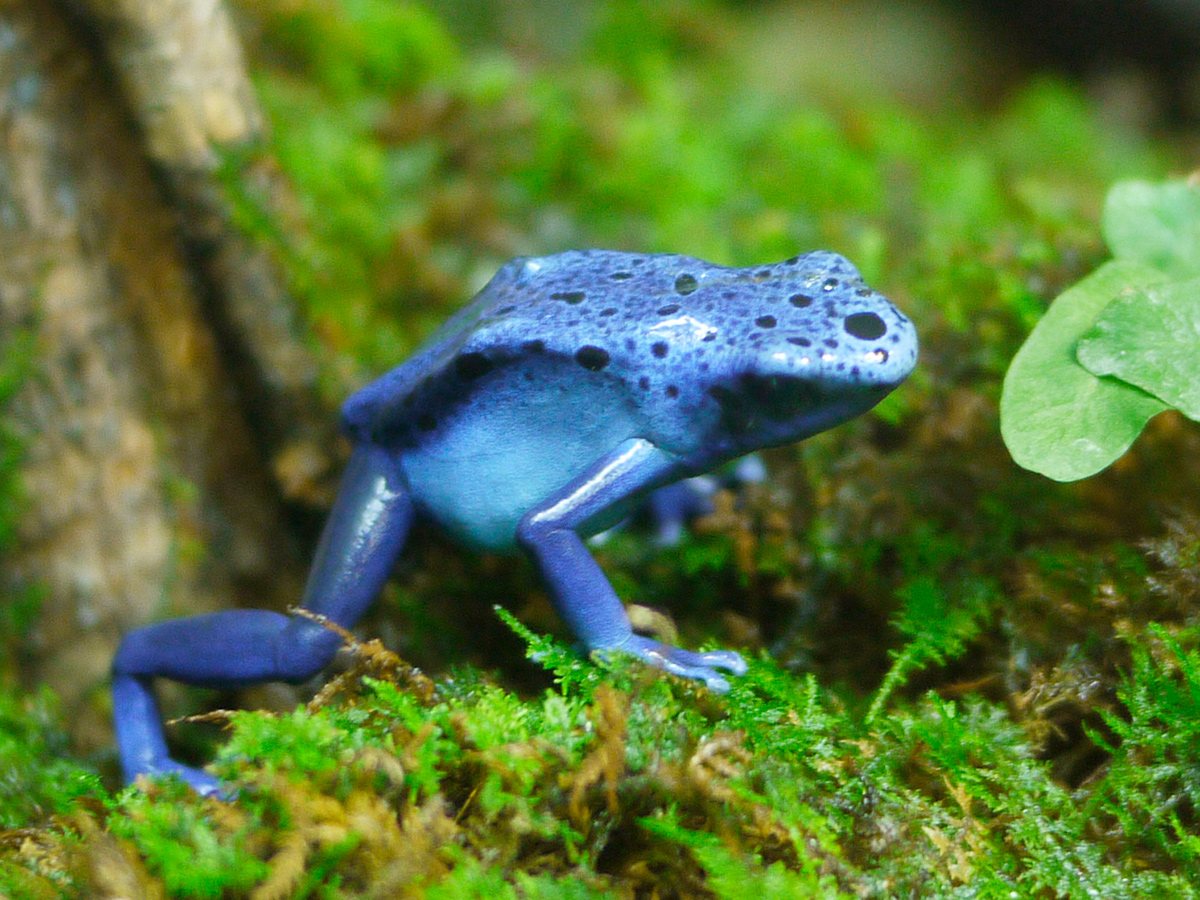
706,251,917,452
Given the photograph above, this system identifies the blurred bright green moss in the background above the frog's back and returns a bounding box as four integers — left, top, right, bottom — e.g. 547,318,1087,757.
233,0,1163,398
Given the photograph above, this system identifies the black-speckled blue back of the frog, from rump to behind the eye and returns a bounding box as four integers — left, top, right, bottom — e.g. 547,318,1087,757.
343,250,914,444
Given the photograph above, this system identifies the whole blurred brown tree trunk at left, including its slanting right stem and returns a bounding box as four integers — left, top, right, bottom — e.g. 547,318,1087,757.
0,0,336,743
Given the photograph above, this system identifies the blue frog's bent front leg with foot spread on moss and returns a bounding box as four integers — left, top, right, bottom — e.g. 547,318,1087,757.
517,439,746,692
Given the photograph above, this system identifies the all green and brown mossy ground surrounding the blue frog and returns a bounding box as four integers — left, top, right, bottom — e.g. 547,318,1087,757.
0,0,1200,900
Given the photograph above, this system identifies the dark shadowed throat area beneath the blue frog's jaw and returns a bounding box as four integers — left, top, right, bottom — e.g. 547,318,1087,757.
708,374,890,444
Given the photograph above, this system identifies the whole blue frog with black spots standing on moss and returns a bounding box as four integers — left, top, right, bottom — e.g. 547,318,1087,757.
113,251,917,792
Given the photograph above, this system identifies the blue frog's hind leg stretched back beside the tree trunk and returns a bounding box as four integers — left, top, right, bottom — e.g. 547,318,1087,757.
113,444,413,793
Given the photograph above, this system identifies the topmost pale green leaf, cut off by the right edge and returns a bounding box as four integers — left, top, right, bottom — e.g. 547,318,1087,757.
1102,181,1200,280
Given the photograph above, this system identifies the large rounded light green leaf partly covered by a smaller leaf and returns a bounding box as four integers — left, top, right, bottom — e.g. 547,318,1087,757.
1000,259,1166,481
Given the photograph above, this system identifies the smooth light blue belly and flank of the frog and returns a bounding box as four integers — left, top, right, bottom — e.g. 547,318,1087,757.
401,385,638,550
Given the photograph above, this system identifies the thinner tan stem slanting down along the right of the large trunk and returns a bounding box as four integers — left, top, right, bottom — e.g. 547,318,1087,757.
73,0,335,505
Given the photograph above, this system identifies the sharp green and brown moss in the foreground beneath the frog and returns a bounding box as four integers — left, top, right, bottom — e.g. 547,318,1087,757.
9,622,1200,900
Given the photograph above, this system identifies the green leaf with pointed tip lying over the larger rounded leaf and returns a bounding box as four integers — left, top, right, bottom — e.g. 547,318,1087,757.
1075,278,1200,420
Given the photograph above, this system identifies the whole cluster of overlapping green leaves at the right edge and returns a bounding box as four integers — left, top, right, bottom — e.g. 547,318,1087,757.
1000,180,1200,481
